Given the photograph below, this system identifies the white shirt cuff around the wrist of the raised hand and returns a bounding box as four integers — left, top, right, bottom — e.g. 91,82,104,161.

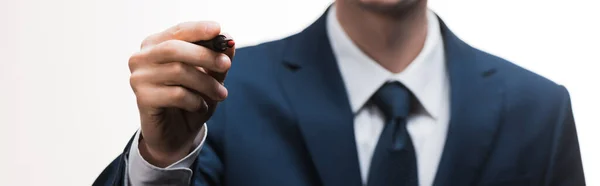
126,123,207,186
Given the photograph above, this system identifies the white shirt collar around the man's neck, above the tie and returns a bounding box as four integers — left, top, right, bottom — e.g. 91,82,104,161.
327,6,449,118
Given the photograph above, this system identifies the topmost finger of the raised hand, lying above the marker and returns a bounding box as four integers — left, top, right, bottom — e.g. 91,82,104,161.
141,21,221,48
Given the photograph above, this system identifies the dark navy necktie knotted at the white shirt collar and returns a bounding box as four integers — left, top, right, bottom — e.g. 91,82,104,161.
367,82,418,186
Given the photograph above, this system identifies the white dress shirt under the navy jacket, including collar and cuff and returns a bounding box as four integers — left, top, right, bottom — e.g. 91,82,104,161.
125,6,450,186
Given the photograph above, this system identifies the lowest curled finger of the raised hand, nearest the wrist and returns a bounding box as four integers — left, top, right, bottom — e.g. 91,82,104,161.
136,85,206,112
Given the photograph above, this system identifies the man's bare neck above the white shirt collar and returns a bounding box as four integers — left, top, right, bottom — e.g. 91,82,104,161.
335,0,427,73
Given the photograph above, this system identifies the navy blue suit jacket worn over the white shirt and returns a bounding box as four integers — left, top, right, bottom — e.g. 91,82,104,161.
94,9,585,186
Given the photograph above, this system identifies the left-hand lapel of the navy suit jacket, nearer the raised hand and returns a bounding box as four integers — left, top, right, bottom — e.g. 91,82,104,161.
279,8,361,186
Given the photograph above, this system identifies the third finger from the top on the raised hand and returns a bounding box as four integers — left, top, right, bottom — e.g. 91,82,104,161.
131,62,227,101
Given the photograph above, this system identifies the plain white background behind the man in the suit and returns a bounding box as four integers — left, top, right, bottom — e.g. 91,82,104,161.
0,0,600,186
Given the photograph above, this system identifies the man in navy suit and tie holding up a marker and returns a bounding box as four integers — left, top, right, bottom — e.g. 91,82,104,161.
94,0,585,186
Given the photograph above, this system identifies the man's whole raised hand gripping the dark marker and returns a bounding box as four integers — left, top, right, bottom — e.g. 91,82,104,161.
129,22,235,167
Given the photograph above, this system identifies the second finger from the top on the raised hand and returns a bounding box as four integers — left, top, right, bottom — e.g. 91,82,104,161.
134,40,231,73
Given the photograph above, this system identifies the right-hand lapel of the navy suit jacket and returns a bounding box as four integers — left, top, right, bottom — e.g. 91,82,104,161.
434,20,503,186
